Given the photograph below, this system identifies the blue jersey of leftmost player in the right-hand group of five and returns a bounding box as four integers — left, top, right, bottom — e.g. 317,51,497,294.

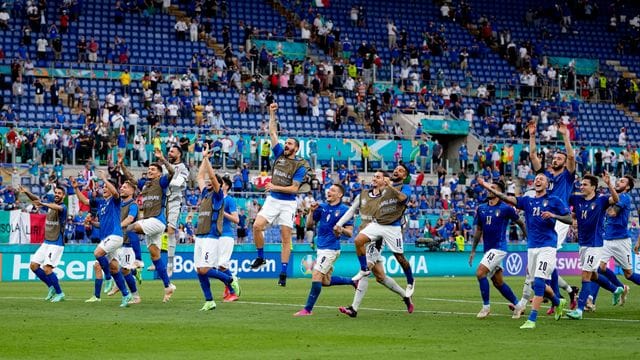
473,202,518,252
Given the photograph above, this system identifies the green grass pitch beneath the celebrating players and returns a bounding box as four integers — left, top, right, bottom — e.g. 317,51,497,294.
0,277,640,360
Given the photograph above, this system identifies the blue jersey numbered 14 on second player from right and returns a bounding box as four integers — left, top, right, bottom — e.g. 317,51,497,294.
569,195,609,247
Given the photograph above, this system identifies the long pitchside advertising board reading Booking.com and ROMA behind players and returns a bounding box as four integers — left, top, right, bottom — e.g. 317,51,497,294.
0,245,640,281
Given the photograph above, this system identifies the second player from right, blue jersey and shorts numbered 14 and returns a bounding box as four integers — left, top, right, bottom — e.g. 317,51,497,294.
567,171,623,320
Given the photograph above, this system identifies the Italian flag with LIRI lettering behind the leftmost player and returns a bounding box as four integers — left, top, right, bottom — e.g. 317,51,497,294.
5,210,46,244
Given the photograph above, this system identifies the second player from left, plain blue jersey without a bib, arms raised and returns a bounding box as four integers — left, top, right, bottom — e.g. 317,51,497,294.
78,170,132,307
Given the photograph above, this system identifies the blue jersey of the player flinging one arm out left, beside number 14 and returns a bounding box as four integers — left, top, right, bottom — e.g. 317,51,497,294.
516,194,569,249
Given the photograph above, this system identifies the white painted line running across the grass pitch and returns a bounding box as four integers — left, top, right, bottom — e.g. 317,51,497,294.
0,296,640,323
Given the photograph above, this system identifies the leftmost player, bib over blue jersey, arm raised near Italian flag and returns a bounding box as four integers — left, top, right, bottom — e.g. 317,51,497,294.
19,186,67,302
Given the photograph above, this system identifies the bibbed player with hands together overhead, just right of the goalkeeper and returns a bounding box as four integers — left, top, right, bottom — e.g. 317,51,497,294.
193,145,239,311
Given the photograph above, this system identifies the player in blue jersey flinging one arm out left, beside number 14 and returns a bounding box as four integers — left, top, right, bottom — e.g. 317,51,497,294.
479,174,572,329
